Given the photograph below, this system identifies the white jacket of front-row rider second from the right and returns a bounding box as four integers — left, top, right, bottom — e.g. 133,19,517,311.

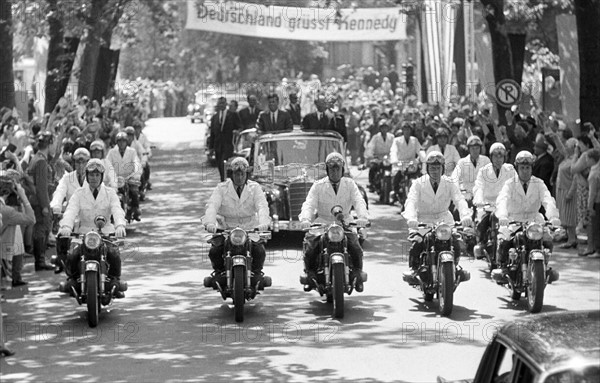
402,174,473,225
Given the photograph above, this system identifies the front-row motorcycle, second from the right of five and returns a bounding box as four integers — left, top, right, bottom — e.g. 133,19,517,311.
403,223,471,316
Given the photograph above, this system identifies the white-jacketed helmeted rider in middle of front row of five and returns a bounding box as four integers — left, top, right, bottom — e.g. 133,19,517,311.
298,152,369,293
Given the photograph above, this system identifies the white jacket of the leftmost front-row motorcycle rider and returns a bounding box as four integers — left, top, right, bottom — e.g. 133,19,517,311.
60,184,126,233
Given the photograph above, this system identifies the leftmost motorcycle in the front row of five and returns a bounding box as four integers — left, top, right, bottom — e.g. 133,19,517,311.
60,216,127,327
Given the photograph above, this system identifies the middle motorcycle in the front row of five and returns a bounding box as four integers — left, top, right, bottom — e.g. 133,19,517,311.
300,205,368,318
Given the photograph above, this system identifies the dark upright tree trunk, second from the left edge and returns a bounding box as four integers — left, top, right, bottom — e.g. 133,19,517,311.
44,0,64,113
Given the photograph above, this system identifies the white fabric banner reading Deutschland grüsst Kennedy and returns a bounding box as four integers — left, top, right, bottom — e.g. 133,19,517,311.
186,0,407,41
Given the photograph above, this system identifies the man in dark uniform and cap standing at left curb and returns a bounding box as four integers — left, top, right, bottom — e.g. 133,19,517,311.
27,132,54,271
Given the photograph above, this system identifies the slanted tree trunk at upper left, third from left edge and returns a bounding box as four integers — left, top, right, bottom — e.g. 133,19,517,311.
77,0,107,102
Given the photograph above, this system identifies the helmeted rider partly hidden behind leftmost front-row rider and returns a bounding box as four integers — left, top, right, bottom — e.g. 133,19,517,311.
50,148,90,274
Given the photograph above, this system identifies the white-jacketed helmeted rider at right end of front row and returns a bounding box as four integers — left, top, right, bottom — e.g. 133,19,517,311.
492,150,560,283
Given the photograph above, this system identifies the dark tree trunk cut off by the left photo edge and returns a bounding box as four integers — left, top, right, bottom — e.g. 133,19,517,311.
0,0,15,109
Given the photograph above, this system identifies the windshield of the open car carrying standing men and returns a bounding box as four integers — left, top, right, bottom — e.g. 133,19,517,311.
256,137,342,166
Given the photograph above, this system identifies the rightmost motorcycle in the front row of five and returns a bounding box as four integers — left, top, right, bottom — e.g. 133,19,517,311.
492,221,559,313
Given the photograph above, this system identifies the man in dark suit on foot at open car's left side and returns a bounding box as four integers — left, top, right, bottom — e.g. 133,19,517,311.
208,97,242,182
